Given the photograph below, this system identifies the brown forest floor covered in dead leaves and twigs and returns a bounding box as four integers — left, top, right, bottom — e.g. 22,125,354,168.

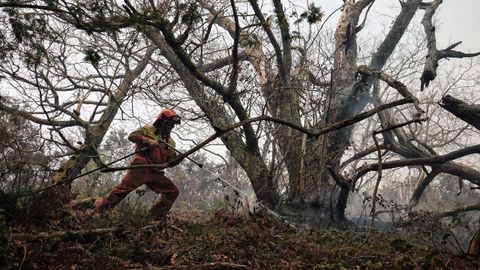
0,206,478,269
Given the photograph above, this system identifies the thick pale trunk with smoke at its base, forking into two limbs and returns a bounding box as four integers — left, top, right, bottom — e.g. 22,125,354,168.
292,0,421,224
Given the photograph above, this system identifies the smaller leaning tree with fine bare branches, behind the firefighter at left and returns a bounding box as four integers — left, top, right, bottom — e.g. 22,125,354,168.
0,3,155,192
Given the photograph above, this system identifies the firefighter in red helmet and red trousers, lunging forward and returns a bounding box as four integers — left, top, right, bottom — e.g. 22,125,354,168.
94,109,180,224
